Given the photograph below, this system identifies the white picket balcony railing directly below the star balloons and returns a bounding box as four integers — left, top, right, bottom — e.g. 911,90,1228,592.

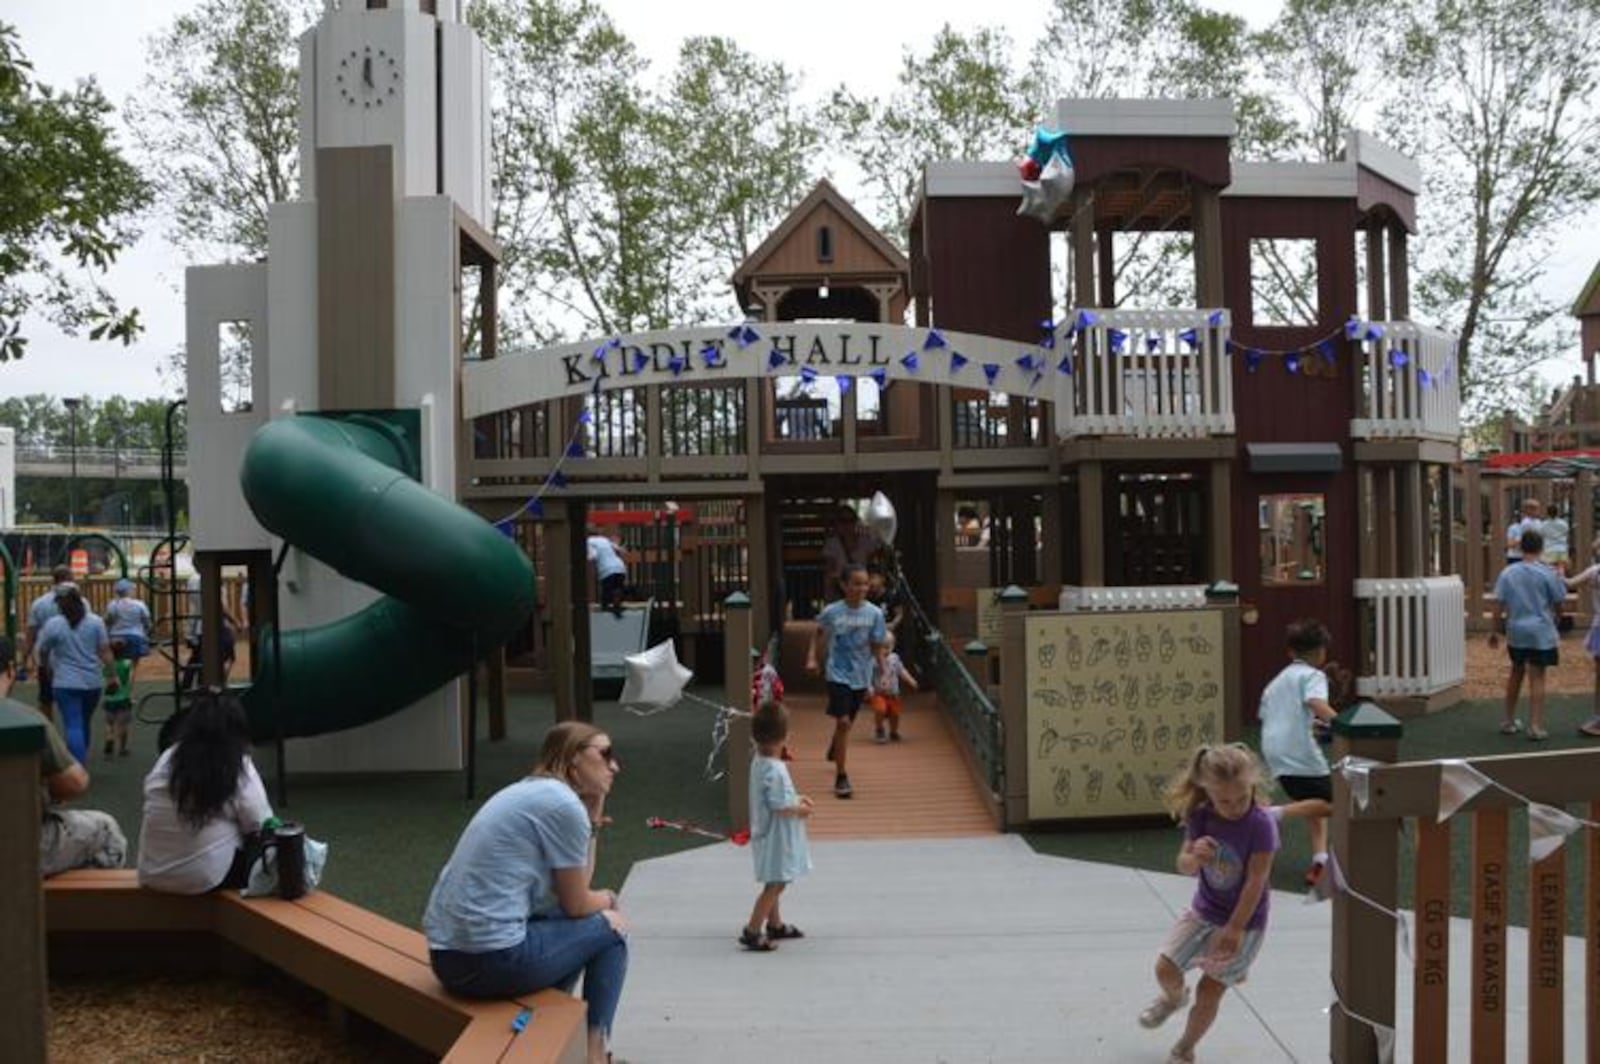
1056,309,1234,438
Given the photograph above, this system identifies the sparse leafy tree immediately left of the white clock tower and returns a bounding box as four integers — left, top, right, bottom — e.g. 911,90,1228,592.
128,0,320,261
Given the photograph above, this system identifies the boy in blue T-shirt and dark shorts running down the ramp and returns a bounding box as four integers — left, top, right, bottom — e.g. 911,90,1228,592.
805,565,888,798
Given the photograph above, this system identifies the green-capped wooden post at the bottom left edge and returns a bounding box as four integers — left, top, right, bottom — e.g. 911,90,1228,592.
0,701,50,1064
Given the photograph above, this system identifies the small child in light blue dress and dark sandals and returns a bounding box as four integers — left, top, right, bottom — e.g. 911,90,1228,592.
739,702,811,954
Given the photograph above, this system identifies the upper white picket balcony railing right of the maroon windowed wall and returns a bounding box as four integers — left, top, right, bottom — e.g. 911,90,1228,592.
1350,322,1461,443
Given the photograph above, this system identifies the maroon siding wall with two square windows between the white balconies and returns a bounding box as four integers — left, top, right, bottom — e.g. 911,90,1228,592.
1222,197,1358,720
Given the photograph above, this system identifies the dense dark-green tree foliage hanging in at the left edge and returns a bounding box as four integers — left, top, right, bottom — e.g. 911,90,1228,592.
0,22,149,362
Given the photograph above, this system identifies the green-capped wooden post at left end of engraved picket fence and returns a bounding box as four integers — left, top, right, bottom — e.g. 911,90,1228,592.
1328,702,1402,1064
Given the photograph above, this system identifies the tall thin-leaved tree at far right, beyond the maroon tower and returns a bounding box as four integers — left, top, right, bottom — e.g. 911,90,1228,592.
1389,0,1600,414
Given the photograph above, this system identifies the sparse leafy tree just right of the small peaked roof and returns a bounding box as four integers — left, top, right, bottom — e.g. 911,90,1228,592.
824,24,1035,246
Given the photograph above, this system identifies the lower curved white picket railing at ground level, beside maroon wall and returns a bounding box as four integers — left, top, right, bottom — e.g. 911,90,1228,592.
1355,576,1467,698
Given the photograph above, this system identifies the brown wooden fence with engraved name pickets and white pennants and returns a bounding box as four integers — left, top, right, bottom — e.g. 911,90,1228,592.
1331,729,1600,1064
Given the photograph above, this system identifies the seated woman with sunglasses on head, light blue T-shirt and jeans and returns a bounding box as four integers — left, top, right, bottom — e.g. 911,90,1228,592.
422,720,627,1064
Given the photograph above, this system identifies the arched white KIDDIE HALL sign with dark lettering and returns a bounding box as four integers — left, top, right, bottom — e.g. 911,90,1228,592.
462,322,1058,418
